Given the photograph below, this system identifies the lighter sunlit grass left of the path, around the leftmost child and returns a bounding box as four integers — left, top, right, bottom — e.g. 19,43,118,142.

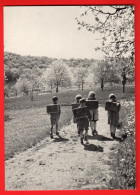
5,107,72,160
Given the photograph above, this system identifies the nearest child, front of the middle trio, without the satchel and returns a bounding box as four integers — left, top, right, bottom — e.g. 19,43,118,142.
77,98,91,144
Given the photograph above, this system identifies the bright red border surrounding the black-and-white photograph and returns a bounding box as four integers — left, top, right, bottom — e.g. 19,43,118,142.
0,0,140,195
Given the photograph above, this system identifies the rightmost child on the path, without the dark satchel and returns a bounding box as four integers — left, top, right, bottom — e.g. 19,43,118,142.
108,94,120,139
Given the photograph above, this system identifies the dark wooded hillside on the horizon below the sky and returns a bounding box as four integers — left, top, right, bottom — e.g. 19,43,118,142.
4,52,96,85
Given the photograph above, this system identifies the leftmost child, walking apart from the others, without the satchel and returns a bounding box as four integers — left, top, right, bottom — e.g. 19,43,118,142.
50,96,61,138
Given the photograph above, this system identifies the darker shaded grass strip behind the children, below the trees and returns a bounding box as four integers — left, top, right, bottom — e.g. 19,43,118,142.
5,86,135,110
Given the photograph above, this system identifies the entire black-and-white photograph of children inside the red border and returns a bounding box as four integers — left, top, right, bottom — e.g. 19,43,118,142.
4,5,136,191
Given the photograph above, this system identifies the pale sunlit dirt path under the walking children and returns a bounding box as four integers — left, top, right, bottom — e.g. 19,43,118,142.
5,108,118,190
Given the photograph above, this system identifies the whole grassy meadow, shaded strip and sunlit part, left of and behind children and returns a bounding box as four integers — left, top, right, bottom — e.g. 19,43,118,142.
5,86,135,159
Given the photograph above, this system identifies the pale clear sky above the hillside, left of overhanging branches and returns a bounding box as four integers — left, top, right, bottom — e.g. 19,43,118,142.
4,6,103,59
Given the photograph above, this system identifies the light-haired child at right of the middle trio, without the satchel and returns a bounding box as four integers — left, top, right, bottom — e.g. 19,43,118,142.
87,91,98,136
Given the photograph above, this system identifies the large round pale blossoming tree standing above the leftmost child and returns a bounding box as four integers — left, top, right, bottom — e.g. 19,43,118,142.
42,59,72,92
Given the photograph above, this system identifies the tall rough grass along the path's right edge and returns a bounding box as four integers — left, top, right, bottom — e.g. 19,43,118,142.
108,101,136,189
